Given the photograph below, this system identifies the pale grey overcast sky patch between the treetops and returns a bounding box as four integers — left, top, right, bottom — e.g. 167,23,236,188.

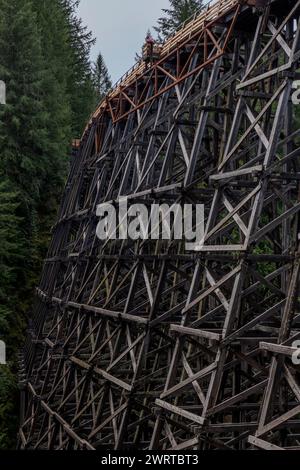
78,0,169,82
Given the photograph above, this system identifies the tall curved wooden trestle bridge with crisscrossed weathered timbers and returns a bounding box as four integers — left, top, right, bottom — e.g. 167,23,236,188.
19,0,300,450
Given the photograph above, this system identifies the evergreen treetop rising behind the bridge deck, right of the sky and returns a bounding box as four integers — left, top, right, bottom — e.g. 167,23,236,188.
154,0,204,40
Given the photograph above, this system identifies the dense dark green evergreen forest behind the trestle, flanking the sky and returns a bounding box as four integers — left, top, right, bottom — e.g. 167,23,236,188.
0,0,203,449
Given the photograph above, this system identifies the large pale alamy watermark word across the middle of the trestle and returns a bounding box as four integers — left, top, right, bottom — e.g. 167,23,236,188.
96,197,204,251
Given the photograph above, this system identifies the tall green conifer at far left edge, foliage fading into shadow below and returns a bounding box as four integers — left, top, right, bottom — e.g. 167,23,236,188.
0,0,49,202
